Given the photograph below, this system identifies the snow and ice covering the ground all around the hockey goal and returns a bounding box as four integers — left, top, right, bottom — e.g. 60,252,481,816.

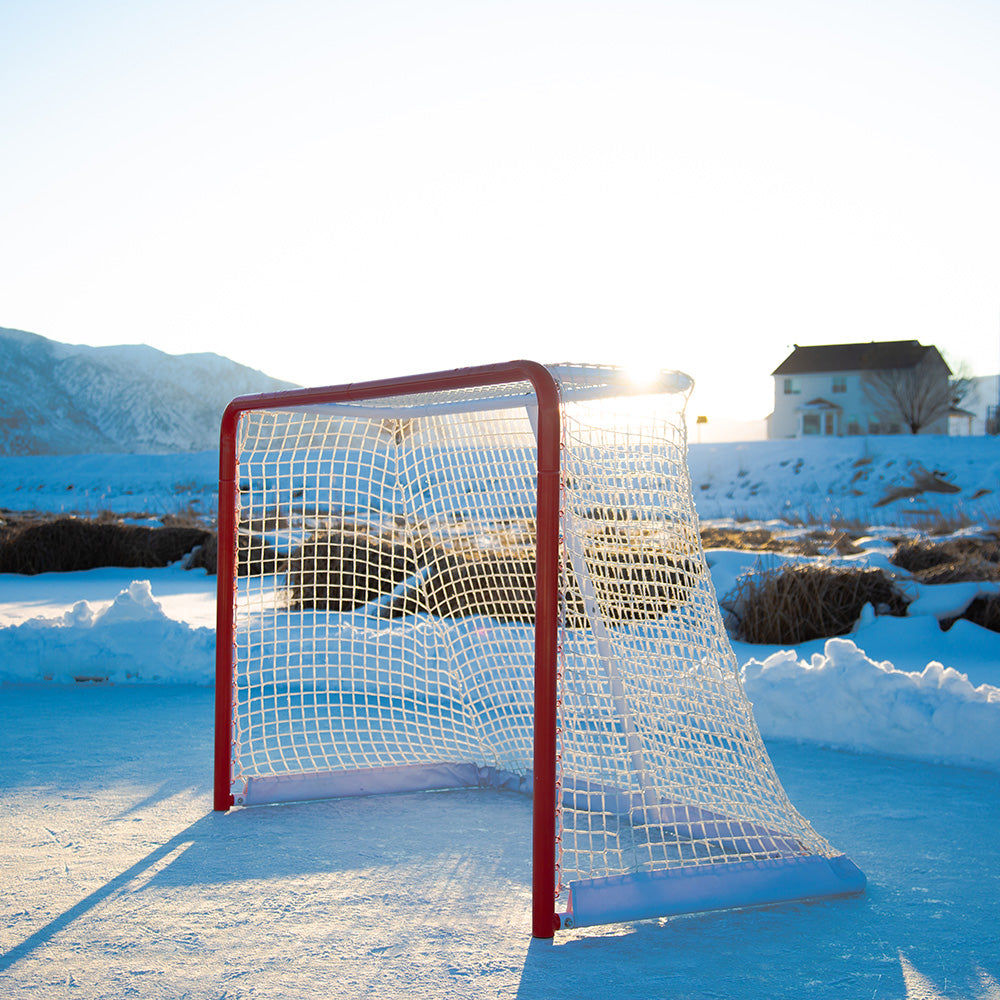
0,438,1000,1000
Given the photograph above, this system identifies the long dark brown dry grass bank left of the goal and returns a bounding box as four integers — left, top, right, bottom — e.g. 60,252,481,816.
0,517,211,575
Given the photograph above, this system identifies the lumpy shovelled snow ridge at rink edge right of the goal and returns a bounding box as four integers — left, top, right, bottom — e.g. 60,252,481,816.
743,639,1000,771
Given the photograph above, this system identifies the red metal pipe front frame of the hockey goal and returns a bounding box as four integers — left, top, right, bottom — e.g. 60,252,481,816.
214,361,561,938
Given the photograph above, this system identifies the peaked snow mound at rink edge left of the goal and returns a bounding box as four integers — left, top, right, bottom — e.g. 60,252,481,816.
0,580,215,684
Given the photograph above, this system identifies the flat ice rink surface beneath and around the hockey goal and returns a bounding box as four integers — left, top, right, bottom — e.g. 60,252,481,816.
0,684,1000,1000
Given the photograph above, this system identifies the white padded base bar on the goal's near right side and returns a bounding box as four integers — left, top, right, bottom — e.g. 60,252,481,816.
561,854,865,927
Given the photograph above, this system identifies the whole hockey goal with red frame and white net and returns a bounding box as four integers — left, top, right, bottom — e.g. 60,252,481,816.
215,361,865,937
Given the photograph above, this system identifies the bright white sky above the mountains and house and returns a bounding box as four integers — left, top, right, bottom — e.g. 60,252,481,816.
0,0,1000,430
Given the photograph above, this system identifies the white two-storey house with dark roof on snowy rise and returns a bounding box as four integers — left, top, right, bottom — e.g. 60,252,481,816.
767,340,951,438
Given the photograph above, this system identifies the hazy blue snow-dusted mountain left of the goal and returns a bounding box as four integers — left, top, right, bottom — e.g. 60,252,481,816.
0,327,292,455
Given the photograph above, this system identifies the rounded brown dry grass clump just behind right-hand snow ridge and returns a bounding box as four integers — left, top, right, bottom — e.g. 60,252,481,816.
734,564,906,645
